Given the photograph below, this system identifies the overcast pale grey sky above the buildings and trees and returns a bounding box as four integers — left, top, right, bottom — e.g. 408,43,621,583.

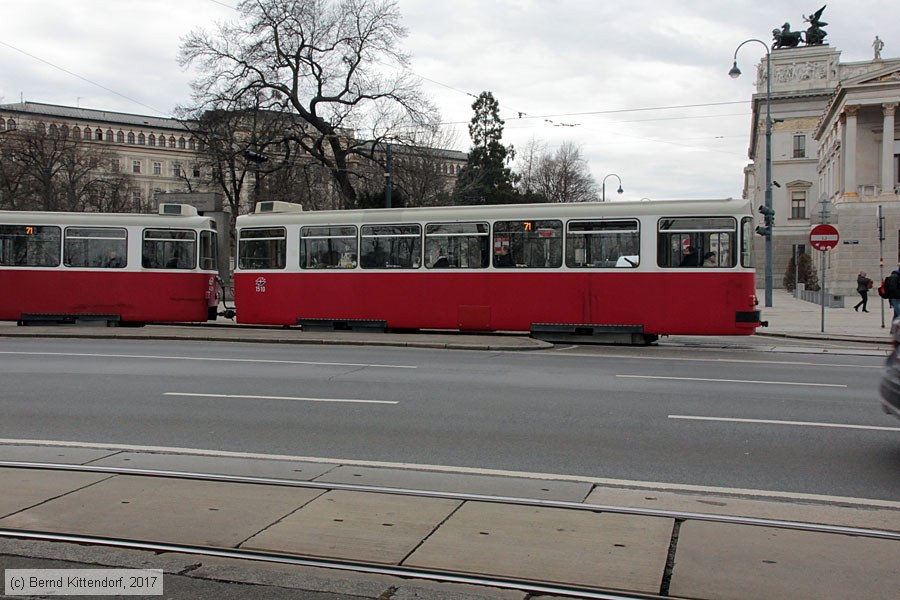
0,0,900,200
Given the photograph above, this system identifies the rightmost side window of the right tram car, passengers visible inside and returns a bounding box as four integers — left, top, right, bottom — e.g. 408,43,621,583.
657,217,738,268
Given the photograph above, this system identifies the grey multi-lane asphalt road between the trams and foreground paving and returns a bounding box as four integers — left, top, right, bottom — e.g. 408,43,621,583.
0,339,900,500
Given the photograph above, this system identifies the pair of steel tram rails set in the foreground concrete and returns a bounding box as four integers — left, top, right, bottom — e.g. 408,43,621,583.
0,460,900,600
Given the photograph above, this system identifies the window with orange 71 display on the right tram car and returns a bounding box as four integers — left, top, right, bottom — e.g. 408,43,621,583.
494,220,562,269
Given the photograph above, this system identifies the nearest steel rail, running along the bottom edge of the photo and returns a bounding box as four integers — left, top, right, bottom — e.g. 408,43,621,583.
0,528,660,600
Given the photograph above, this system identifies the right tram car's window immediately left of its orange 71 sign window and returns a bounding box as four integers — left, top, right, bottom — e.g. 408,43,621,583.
425,223,491,269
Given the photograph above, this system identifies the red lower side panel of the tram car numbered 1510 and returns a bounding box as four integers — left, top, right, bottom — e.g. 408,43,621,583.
235,270,759,335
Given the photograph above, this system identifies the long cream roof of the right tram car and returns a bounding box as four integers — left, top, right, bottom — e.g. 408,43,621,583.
237,198,752,226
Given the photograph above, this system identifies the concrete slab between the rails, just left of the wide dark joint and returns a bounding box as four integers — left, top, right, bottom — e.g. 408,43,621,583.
403,502,674,593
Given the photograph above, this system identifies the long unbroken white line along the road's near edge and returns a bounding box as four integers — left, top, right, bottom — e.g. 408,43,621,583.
0,438,900,510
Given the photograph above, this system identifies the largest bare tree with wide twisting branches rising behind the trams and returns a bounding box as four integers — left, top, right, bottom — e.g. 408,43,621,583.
180,0,439,207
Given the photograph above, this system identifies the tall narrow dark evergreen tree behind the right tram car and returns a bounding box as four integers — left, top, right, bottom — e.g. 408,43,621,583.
453,92,518,204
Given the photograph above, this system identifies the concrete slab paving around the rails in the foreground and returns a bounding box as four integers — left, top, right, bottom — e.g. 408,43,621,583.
0,445,900,600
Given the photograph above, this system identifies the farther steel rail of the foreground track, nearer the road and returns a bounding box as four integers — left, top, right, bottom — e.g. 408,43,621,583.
0,460,900,541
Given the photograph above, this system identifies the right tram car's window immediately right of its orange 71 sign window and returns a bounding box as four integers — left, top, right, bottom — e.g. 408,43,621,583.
566,220,641,268
